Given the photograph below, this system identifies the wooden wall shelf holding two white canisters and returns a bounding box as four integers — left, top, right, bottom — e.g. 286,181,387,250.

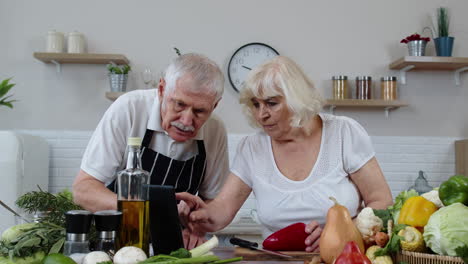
33,52,130,72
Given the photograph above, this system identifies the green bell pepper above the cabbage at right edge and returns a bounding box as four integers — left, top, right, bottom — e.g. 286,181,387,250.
439,175,468,206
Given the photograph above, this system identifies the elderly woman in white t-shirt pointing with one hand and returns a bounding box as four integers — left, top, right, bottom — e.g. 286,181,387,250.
177,56,392,251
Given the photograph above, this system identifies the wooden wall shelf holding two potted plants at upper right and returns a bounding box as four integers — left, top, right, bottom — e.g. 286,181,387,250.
389,56,468,85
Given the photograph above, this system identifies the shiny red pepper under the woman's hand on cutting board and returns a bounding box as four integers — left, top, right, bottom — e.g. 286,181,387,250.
263,223,309,251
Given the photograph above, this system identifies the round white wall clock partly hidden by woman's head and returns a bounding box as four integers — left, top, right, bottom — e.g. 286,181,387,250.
228,43,279,92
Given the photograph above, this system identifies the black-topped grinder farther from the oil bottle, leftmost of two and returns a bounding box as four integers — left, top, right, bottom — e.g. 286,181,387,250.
63,210,93,256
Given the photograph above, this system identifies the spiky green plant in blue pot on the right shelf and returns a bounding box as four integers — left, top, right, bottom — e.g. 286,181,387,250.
432,7,455,57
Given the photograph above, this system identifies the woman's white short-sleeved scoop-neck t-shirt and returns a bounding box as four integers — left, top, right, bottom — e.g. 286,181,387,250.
231,114,375,237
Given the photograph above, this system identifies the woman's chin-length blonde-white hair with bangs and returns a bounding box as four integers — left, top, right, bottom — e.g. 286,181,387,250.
239,56,324,132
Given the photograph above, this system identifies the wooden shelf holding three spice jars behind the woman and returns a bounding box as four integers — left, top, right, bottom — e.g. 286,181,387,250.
325,99,408,117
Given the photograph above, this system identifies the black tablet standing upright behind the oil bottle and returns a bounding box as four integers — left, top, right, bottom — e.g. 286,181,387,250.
148,185,184,255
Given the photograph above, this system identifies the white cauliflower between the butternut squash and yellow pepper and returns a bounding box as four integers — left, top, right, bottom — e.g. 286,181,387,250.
356,207,383,244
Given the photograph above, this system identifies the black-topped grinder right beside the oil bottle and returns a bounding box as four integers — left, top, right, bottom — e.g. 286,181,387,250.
94,210,122,254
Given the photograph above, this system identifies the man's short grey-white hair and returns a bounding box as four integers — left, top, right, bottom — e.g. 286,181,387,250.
164,53,224,102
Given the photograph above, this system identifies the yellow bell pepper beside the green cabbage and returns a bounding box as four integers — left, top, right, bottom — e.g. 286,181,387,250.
398,196,437,227
